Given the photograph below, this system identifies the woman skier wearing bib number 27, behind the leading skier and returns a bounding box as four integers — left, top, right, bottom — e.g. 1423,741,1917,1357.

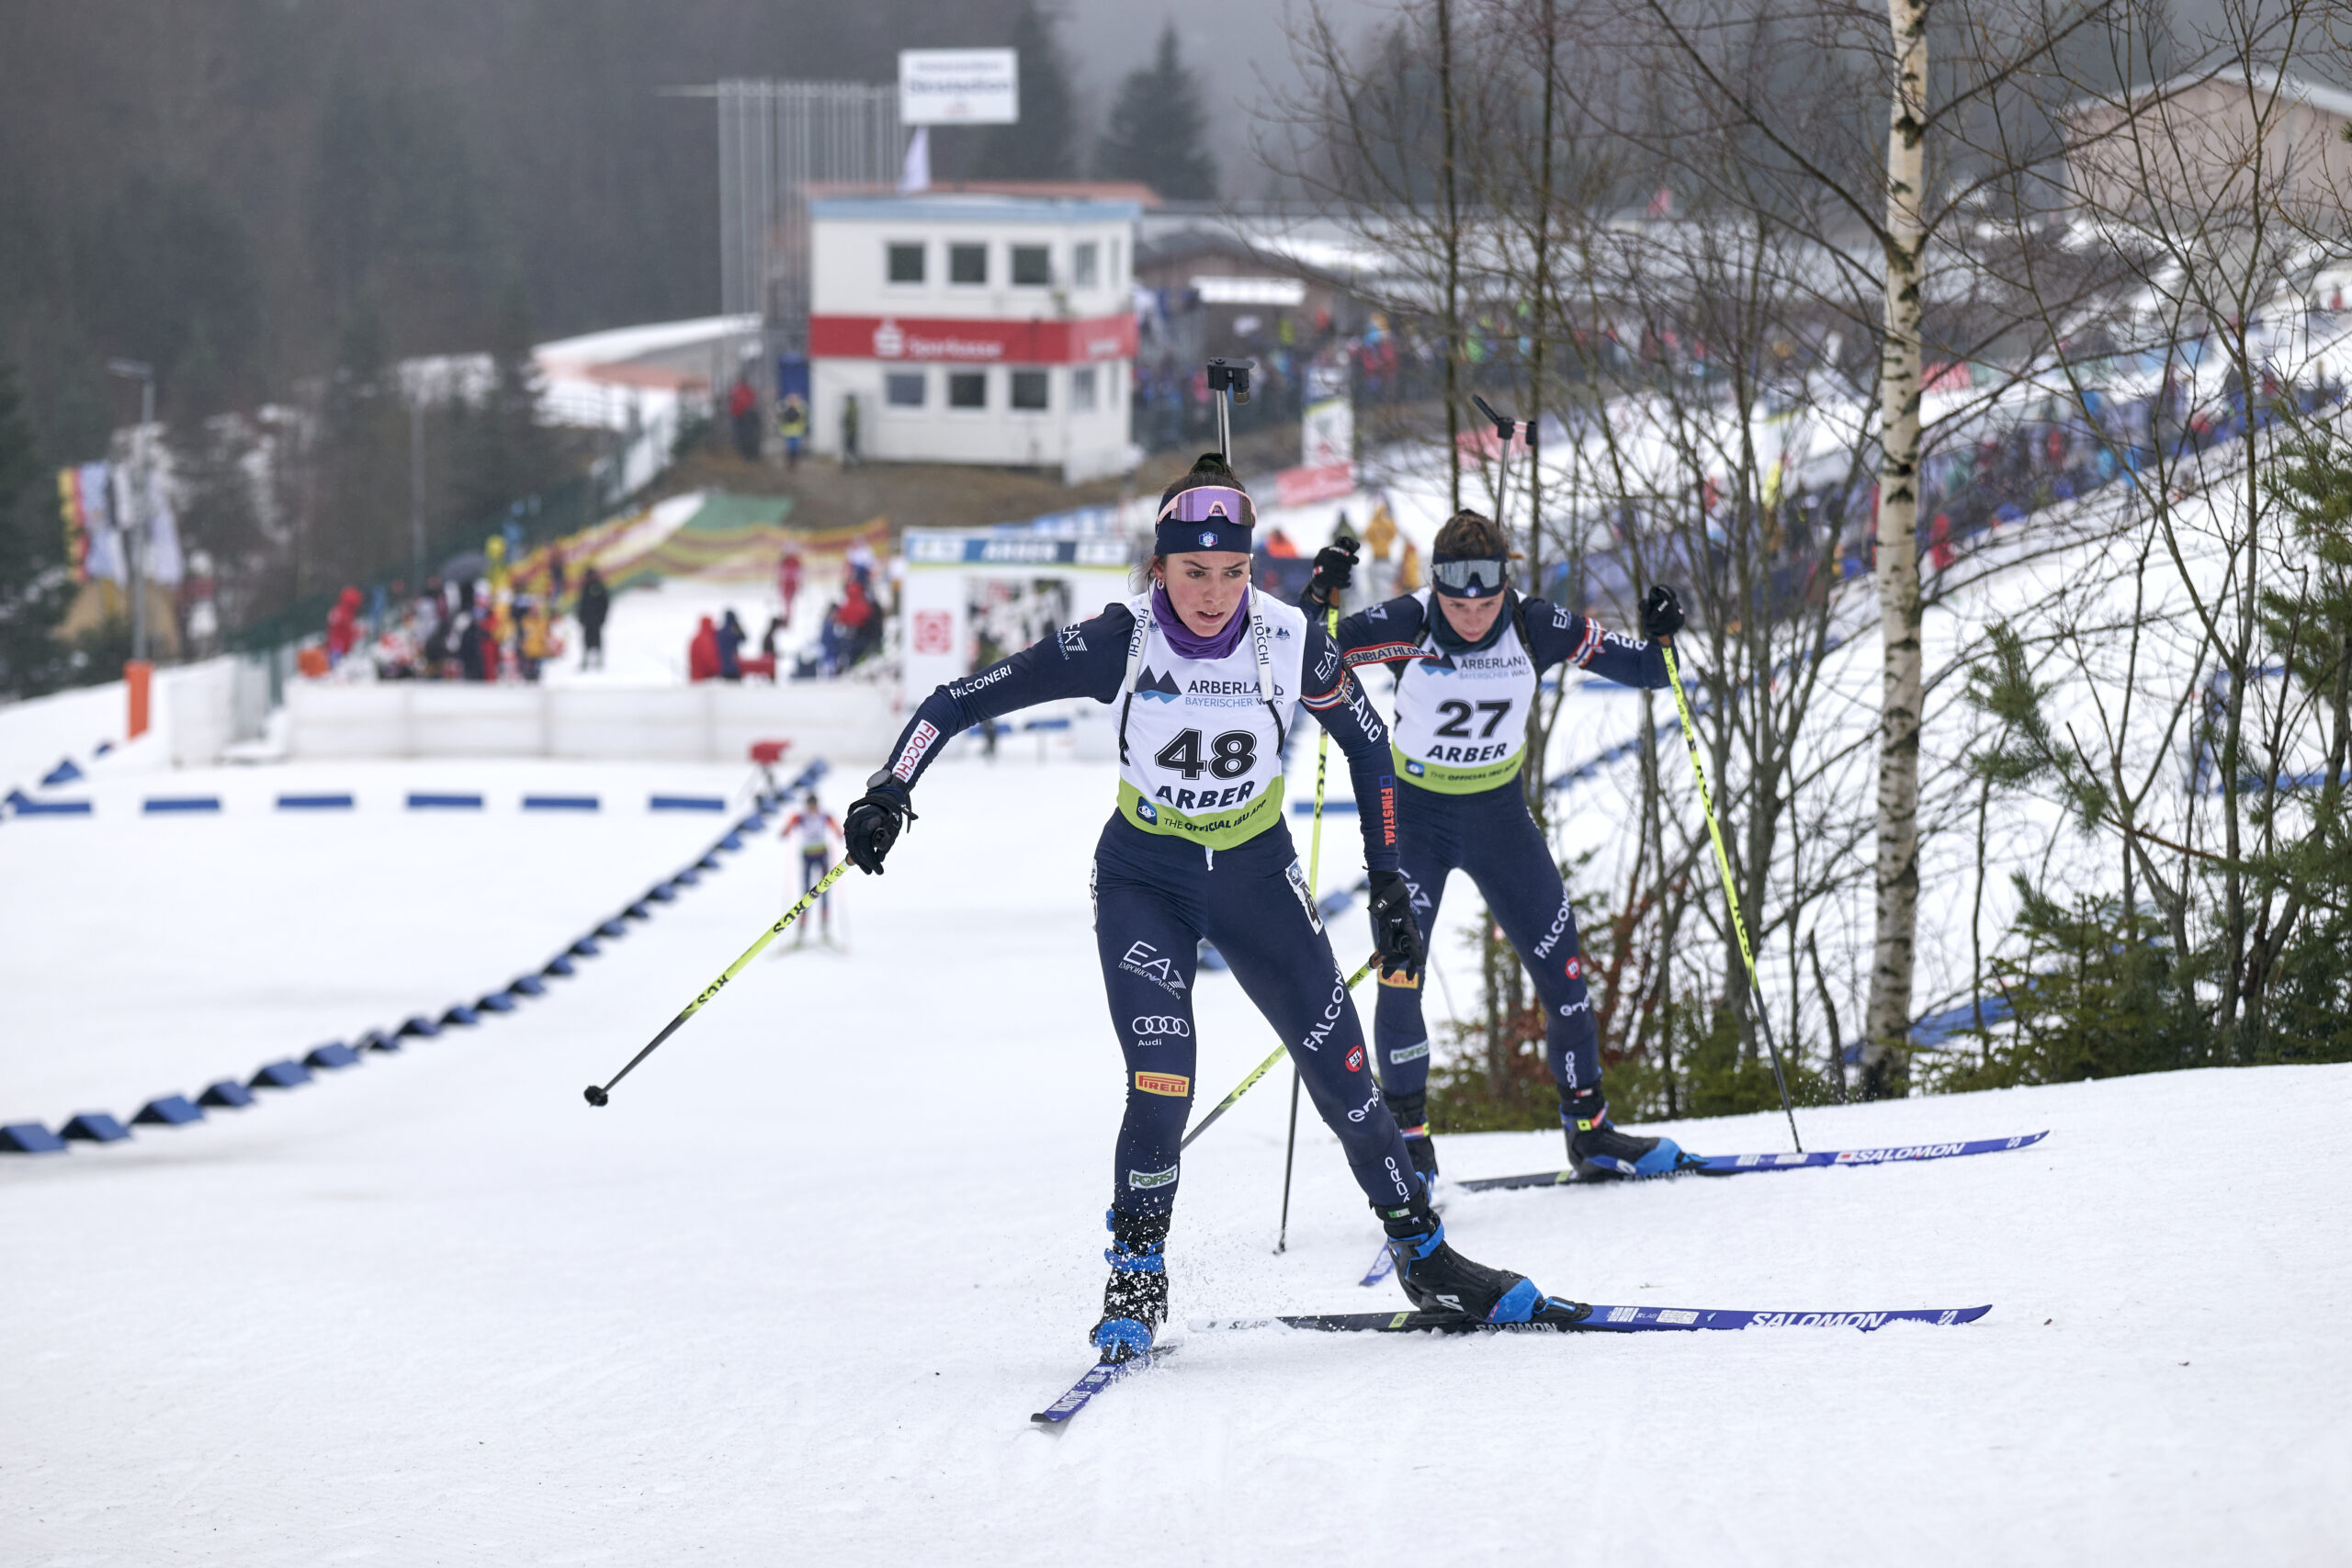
1301,510,1684,1182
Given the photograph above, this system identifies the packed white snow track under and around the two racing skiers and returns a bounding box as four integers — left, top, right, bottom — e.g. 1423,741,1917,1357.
0,745,2352,1565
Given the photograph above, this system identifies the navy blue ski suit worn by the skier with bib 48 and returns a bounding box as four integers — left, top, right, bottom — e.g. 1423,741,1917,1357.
870,604,1416,1215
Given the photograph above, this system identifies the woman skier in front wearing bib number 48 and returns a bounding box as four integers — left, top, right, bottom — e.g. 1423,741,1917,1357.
842,454,1562,1361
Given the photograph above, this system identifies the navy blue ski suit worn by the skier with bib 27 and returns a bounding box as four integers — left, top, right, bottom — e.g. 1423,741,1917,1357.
1339,592,1665,1114
